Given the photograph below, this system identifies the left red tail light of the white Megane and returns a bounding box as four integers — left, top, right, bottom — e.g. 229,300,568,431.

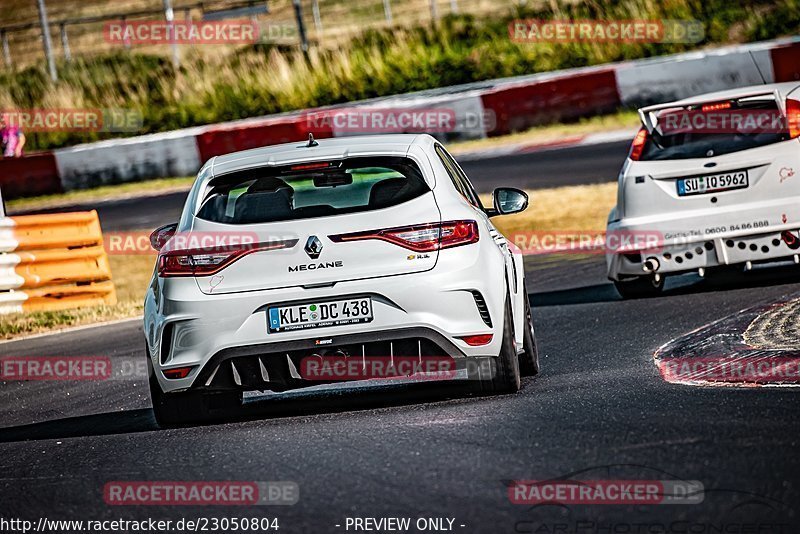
157,239,297,278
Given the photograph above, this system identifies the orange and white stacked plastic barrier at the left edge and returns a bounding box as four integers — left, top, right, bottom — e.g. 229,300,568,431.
0,211,116,313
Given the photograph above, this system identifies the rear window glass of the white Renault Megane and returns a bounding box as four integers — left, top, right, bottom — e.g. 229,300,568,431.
197,157,430,224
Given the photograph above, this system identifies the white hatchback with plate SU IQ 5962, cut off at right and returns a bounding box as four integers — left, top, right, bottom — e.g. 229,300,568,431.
606,82,800,298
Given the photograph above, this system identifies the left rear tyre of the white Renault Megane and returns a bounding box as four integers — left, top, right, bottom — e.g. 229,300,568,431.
147,355,242,428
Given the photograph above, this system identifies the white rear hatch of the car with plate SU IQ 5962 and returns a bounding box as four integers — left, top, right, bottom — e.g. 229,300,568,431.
621,90,800,218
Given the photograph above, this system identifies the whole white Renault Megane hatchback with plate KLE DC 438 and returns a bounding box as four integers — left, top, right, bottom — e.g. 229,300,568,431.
144,135,539,424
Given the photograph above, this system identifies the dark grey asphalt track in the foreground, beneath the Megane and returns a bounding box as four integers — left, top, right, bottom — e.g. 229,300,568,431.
0,140,800,534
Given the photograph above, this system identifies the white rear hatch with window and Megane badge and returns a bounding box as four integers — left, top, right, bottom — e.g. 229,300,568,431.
169,156,446,294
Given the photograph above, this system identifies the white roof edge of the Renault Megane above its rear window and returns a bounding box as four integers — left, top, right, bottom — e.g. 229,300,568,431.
203,134,436,176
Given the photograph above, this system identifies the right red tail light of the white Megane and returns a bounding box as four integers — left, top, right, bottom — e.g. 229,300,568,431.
328,221,479,252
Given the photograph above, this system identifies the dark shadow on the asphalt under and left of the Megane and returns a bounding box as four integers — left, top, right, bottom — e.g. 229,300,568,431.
0,378,535,443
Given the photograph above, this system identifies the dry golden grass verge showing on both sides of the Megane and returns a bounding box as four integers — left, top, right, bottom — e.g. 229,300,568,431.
0,184,616,339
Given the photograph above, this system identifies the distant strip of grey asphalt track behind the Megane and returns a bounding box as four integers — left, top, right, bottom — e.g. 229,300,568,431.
9,141,630,232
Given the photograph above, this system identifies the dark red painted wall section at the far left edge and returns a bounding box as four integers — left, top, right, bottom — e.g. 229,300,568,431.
0,152,64,200
